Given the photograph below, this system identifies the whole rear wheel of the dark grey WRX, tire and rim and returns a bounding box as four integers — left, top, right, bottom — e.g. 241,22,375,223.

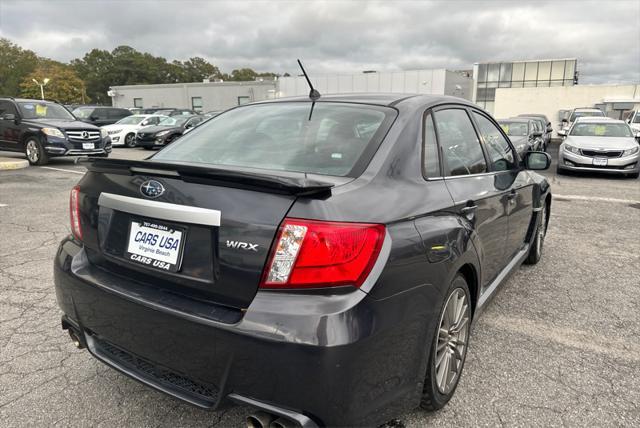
420,274,471,411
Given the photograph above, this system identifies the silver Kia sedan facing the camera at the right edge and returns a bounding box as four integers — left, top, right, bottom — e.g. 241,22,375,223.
558,117,640,178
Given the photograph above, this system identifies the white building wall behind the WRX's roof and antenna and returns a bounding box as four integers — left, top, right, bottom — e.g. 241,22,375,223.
277,69,472,99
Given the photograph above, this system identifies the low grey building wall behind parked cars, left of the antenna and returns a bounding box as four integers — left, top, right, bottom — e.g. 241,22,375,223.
111,82,276,112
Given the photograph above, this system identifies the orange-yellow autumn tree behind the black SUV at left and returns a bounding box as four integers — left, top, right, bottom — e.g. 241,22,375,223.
20,60,90,104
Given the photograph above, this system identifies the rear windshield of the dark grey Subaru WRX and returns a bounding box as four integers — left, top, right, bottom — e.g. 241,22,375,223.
153,102,396,177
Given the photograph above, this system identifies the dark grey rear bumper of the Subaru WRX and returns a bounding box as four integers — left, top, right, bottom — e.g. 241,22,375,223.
54,240,432,426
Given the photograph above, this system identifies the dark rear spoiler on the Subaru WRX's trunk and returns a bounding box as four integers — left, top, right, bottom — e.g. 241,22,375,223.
80,158,342,197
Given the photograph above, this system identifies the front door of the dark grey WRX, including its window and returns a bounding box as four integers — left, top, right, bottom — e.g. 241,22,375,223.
472,109,533,262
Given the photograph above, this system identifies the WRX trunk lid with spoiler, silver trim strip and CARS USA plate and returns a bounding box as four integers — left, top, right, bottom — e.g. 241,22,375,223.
80,159,340,309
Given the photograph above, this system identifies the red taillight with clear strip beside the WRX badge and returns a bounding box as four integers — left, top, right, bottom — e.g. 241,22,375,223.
260,218,385,288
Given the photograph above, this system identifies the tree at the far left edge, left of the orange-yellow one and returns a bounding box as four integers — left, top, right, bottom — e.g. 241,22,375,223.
0,39,38,97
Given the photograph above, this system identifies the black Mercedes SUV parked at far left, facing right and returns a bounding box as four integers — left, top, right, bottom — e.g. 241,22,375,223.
0,97,111,165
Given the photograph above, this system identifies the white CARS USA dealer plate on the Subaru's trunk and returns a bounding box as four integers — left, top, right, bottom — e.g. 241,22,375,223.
126,221,185,272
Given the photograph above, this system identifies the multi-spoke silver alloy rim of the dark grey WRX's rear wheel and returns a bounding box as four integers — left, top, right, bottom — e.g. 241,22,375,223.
435,288,470,394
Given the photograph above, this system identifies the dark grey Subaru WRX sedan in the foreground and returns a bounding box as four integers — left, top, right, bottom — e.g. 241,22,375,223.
54,94,551,427
